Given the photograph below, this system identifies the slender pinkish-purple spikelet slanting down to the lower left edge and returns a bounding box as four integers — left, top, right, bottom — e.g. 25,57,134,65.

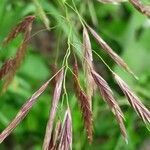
0,79,51,143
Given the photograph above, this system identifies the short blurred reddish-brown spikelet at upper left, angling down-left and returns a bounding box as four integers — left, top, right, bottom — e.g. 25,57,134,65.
3,16,35,45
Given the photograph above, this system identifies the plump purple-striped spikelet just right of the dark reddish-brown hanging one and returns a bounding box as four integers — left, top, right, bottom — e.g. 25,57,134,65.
91,70,127,141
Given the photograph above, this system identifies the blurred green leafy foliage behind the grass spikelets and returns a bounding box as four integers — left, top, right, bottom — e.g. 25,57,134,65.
0,0,150,150
